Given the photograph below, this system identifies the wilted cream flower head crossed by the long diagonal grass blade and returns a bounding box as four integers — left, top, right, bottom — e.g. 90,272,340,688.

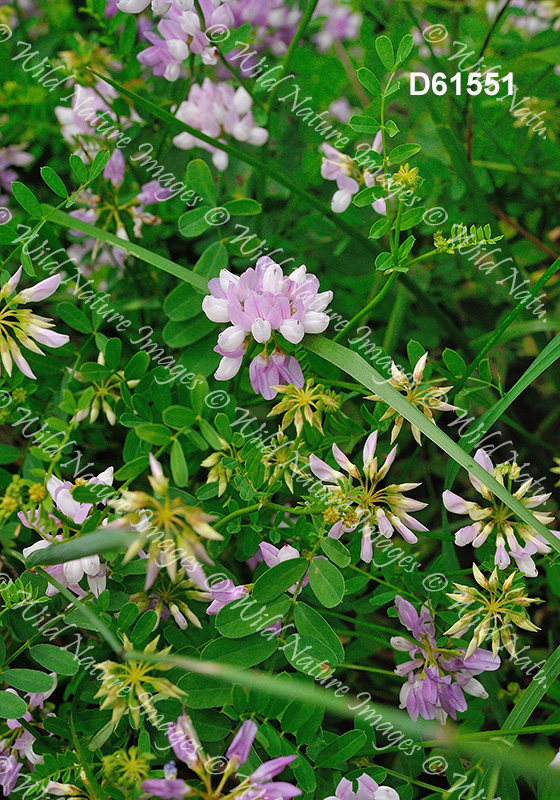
366,353,456,445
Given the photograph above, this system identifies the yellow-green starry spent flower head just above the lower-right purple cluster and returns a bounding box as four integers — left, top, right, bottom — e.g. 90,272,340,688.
446,564,543,657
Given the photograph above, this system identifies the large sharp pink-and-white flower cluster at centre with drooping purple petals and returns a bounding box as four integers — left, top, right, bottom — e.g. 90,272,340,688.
202,256,332,400
